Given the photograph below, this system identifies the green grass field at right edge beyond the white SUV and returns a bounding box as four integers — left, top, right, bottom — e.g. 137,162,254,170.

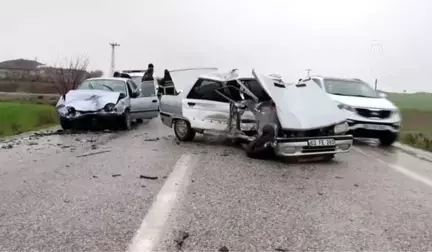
389,93,432,151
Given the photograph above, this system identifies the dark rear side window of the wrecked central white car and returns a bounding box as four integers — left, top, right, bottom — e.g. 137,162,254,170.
187,79,228,102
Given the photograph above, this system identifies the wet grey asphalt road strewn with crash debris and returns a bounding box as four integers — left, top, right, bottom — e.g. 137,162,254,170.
0,119,432,252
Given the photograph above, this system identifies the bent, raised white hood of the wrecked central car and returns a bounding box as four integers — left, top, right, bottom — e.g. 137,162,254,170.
252,70,346,130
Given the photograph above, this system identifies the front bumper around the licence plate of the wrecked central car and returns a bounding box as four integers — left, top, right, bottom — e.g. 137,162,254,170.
273,135,353,157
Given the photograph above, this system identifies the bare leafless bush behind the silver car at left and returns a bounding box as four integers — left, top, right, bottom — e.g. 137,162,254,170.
52,57,90,95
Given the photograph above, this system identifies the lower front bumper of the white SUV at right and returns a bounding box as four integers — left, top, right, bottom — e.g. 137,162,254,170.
348,120,400,138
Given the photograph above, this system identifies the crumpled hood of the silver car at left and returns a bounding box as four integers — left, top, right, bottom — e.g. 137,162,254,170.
60,90,120,111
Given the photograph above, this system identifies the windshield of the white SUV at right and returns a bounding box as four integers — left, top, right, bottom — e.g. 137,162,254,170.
324,79,379,98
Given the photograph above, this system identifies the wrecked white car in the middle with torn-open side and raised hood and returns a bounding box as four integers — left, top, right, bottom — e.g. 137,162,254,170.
160,68,353,159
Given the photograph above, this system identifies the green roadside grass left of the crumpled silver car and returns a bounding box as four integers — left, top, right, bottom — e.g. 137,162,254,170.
0,101,58,137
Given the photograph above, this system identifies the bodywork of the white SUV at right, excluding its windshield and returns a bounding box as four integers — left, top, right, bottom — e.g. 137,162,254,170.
311,76,402,144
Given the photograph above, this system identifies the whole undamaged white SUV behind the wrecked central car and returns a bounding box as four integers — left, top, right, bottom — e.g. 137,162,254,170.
309,76,402,146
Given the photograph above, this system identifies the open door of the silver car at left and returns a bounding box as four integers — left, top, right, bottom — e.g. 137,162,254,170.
129,80,159,119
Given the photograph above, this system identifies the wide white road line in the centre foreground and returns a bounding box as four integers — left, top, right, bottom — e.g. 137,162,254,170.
127,154,194,252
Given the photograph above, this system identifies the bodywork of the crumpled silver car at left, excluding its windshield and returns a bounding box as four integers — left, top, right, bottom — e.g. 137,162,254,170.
56,77,159,129
